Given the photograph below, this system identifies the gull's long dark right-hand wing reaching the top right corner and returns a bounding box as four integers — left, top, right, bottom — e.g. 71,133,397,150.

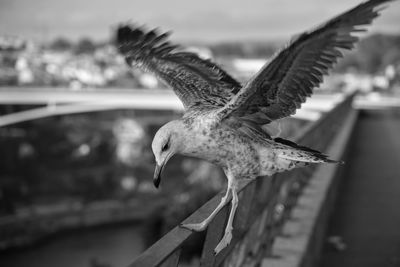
219,0,391,125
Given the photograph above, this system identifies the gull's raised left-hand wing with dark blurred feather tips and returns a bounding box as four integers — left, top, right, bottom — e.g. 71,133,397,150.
117,25,241,109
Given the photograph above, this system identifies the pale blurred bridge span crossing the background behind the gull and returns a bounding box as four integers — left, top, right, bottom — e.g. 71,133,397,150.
0,87,345,127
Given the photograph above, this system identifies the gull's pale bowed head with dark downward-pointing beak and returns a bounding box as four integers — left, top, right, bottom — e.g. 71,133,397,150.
151,121,182,188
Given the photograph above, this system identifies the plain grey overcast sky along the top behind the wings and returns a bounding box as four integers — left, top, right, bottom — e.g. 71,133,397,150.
0,0,400,42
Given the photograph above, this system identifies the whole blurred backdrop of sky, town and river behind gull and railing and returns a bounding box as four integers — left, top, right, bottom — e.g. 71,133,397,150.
0,0,400,267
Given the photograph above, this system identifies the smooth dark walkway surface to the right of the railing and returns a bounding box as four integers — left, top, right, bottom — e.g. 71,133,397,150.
319,110,400,267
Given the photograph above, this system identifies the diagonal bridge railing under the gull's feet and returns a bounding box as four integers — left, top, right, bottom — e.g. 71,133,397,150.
129,95,353,267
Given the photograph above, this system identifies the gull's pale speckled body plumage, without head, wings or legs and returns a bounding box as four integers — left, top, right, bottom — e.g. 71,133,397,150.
178,116,306,180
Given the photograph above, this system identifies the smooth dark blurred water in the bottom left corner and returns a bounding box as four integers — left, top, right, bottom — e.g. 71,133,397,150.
0,224,145,267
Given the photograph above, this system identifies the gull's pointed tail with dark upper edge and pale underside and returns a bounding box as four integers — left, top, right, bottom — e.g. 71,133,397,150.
274,138,343,165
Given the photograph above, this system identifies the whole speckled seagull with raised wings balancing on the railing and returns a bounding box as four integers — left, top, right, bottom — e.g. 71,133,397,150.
117,0,392,253
